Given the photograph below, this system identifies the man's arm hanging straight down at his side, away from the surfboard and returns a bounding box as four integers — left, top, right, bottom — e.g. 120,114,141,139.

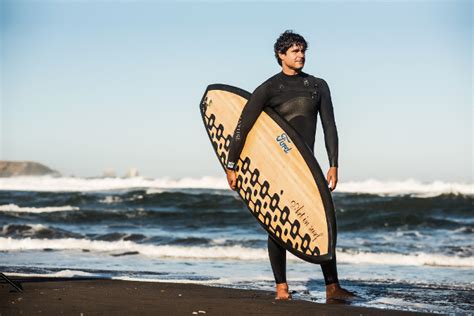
319,79,339,191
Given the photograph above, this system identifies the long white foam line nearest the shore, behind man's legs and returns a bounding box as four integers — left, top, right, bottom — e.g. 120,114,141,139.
0,237,474,268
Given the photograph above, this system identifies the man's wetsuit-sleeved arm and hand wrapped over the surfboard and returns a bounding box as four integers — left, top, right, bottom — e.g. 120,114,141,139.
226,83,268,190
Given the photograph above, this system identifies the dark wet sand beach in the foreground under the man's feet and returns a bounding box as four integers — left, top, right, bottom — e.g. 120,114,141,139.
0,277,432,316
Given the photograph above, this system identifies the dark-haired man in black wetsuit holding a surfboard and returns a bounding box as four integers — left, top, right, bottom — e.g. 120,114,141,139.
226,31,354,300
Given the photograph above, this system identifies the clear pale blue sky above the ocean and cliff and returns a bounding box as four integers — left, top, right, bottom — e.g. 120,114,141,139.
0,0,473,183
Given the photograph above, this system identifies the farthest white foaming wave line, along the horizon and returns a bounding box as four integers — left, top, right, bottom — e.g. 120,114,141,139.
0,175,474,196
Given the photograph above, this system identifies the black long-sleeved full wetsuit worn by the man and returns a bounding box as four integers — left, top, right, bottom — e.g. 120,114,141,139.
227,72,338,285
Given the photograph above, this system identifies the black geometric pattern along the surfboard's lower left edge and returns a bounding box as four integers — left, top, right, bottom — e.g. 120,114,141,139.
201,97,320,256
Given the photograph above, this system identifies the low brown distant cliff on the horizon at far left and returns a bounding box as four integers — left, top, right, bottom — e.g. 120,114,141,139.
0,160,61,177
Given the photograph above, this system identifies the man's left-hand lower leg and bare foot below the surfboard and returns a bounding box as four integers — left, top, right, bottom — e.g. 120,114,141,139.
268,235,290,299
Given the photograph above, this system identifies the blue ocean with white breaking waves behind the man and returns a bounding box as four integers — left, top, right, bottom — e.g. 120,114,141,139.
0,177,474,314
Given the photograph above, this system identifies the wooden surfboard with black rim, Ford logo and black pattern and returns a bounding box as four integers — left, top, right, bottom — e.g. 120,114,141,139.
199,84,336,263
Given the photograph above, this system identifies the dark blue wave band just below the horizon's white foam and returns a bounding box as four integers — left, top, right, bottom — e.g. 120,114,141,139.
0,189,466,234
